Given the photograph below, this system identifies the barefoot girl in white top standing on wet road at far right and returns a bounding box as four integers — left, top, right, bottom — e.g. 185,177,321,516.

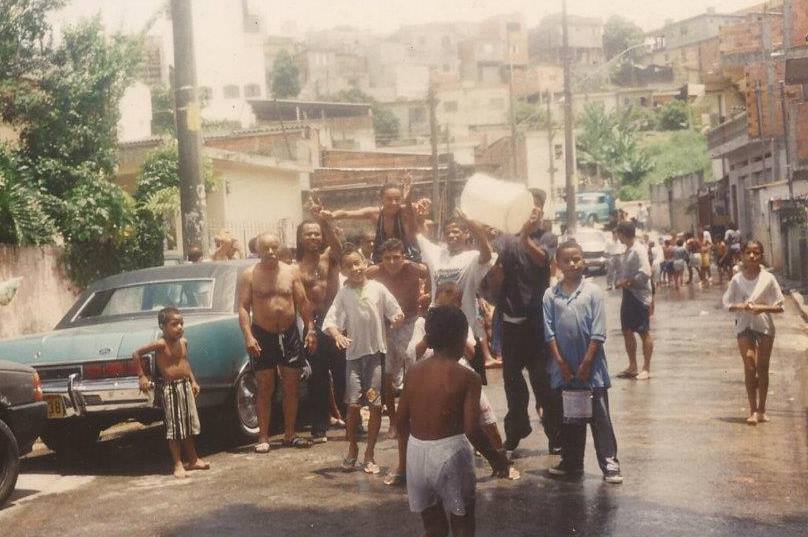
724,240,784,425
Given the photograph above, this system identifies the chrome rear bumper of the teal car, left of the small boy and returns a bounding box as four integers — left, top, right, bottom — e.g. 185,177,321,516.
42,375,153,419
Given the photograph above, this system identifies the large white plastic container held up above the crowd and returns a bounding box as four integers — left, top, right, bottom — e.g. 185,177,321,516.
460,173,533,233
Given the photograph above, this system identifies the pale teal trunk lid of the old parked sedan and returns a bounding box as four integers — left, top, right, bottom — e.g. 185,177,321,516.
0,316,230,366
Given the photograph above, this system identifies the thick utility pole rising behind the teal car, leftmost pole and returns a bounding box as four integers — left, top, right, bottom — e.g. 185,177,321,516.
171,0,208,255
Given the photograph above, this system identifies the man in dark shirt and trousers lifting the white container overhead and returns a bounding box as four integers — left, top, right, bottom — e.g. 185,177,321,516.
486,190,561,454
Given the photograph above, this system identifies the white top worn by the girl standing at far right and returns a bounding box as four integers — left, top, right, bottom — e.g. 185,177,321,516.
723,269,785,336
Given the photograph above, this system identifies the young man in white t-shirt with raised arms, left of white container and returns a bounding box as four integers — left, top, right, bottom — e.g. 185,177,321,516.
416,202,496,383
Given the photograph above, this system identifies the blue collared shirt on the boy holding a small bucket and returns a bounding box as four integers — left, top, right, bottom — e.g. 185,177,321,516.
542,278,611,389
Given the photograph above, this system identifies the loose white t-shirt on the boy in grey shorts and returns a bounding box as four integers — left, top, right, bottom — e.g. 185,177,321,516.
323,280,402,360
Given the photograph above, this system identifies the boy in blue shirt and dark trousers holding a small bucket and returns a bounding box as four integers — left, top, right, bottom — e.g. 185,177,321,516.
542,241,623,483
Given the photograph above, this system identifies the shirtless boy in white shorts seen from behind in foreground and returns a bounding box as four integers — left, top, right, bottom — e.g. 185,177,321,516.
398,306,496,537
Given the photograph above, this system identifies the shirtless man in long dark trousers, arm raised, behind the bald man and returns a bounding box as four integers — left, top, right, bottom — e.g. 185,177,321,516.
297,203,345,443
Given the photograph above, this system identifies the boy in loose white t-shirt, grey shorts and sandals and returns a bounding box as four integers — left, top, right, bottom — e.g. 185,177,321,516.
323,246,404,474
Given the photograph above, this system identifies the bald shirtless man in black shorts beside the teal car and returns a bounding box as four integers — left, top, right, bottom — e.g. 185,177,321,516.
239,233,317,453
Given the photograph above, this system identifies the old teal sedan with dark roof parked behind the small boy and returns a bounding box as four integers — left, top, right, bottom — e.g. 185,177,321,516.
0,261,268,452
